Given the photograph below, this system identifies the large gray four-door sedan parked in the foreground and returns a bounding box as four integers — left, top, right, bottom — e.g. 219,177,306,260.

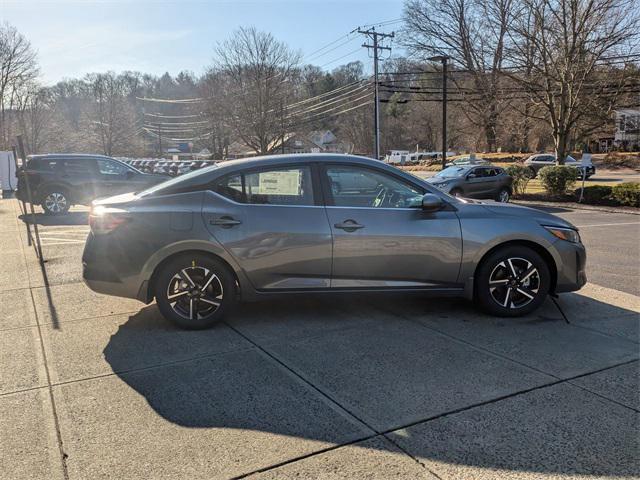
83,154,586,328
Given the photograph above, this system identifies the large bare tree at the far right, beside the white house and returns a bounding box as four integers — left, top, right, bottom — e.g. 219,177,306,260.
510,0,640,164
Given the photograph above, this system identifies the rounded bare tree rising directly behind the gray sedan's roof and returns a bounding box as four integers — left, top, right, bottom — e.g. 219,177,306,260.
213,27,300,154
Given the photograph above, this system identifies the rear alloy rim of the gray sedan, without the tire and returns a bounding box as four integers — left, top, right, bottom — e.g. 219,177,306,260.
167,267,224,320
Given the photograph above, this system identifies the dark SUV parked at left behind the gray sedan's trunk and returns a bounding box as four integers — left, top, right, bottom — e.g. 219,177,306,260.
16,154,170,215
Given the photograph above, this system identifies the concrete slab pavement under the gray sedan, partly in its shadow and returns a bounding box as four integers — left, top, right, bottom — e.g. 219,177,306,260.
0,200,640,480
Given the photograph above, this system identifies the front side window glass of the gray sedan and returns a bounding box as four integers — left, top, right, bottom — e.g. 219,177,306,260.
327,166,424,208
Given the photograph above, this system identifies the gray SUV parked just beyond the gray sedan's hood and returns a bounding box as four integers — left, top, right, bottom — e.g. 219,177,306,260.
427,165,513,203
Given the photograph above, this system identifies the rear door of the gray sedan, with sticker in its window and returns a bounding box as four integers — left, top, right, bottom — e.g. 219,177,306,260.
203,167,332,290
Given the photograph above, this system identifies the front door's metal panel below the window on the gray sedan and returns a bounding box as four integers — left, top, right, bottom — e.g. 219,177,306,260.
327,207,462,288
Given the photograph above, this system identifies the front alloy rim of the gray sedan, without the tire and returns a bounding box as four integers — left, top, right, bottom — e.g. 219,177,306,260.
489,257,541,309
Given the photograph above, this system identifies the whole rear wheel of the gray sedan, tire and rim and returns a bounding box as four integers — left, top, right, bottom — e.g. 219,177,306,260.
154,253,236,330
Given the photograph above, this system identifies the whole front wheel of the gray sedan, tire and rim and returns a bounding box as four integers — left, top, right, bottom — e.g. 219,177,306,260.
474,245,551,317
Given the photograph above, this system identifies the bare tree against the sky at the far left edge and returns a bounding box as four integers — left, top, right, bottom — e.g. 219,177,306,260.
0,22,38,150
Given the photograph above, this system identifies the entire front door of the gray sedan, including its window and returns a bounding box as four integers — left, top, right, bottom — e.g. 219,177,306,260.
322,165,462,288
